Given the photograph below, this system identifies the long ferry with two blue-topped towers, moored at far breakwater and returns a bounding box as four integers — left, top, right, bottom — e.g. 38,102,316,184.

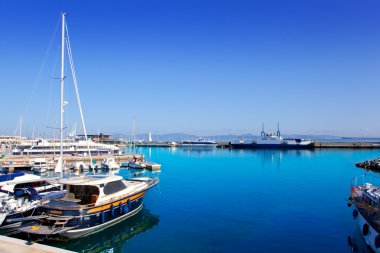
230,125,314,149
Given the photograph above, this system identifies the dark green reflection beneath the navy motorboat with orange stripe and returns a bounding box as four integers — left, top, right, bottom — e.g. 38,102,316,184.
48,208,159,253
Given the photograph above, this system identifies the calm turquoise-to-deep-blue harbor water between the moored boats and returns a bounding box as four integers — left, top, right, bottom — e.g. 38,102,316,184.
39,148,380,252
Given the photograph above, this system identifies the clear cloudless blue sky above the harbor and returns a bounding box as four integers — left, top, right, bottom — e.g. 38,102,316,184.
0,0,380,136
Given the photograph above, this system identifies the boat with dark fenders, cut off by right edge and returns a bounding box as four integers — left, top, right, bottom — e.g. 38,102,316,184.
348,178,380,253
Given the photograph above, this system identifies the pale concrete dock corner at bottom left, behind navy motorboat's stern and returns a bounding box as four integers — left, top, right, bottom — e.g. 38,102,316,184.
0,236,74,253
